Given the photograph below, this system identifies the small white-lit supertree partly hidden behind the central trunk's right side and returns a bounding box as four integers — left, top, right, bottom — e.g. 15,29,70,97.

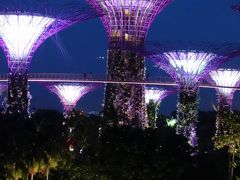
145,87,172,128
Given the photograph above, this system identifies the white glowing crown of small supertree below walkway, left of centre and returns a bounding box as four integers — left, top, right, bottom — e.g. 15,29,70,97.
49,84,92,107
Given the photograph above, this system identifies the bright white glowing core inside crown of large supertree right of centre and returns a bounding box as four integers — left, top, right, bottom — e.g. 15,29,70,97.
164,51,216,76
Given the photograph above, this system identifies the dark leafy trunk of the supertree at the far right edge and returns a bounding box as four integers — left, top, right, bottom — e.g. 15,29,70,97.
215,93,232,136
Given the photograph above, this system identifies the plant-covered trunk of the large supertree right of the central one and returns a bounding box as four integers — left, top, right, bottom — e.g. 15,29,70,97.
177,85,199,147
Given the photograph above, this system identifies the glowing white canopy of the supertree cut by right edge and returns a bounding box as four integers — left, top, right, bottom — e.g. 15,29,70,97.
210,69,240,96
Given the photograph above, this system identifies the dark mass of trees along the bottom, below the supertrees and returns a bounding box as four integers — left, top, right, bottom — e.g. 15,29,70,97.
0,110,234,180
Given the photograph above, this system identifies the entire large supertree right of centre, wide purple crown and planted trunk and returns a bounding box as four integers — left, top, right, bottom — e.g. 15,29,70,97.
148,43,238,148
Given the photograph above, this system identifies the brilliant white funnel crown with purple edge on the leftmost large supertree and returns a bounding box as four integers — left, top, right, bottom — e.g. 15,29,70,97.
0,12,76,70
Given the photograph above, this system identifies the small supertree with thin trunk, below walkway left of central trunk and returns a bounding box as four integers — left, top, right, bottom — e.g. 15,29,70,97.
45,83,97,151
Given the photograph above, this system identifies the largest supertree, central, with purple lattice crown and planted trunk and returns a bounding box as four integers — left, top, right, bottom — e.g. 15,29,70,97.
86,0,172,127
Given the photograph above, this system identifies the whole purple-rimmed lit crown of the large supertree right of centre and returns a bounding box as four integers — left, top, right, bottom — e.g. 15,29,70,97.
153,50,220,86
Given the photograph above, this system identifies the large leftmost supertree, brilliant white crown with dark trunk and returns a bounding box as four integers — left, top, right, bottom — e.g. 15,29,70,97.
0,0,97,117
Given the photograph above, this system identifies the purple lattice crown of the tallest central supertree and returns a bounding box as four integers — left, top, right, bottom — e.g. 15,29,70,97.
87,0,172,41
